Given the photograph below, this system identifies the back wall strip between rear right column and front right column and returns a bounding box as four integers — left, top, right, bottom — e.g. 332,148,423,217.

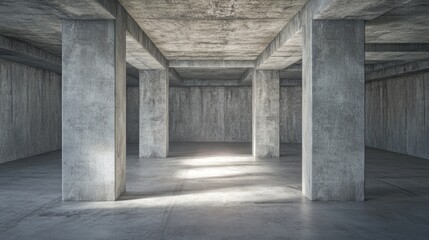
280,86,302,143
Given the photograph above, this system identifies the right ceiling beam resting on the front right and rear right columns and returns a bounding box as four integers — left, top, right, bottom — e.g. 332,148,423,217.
256,0,411,70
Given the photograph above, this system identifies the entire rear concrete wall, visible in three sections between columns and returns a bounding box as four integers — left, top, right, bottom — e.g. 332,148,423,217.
127,86,301,143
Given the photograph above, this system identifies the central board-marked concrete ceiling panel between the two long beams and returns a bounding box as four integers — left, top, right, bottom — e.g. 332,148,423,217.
120,0,306,60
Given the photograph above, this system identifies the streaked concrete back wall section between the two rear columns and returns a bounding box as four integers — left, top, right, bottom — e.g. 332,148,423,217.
169,87,252,142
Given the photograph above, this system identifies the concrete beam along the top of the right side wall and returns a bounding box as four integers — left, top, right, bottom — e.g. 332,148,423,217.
365,60,429,82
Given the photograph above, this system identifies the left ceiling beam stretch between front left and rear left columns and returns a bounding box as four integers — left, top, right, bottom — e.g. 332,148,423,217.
120,6,168,70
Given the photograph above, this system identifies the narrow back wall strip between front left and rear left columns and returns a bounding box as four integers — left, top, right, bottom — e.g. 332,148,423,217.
127,87,139,143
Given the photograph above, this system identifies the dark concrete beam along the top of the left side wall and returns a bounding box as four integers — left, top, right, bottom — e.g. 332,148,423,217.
0,36,61,73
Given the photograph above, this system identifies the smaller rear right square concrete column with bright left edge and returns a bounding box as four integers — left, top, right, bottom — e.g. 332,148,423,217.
252,70,280,157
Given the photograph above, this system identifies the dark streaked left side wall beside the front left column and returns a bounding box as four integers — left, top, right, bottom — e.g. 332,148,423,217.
0,59,61,163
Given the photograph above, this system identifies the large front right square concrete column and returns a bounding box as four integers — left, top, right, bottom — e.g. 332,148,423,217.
302,20,365,201
